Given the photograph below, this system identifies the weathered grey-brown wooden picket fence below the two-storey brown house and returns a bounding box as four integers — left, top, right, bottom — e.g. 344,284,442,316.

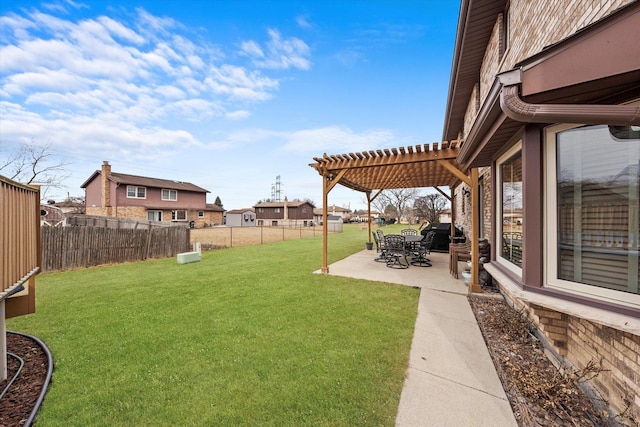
42,226,189,271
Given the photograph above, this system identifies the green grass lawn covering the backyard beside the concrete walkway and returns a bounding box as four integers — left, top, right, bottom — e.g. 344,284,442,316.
8,226,419,426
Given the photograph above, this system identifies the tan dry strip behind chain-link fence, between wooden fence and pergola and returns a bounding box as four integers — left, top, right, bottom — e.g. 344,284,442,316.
190,226,322,249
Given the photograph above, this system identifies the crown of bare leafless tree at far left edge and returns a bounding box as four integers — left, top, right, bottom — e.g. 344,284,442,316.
0,140,69,198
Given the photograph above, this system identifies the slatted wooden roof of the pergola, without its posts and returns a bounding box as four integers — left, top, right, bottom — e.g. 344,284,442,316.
309,140,466,192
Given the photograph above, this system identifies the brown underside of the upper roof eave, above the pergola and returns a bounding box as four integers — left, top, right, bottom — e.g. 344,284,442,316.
442,0,507,141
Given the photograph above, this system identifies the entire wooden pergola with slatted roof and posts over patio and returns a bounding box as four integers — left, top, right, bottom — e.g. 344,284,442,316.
309,140,480,292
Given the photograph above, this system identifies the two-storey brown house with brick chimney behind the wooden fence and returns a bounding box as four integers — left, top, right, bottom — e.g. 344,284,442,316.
81,161,224,227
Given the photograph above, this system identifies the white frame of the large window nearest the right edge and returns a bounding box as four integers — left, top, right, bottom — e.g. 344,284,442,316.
543,124,640,308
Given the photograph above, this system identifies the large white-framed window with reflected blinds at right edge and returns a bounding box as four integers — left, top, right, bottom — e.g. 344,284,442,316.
545,125,640,306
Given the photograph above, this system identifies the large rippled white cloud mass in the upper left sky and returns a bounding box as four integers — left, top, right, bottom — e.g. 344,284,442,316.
0,3,310,175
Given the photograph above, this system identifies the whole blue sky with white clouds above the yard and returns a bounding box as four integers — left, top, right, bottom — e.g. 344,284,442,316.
0,0,459,209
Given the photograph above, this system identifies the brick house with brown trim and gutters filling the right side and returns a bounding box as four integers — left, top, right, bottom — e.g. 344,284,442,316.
443,0,640,414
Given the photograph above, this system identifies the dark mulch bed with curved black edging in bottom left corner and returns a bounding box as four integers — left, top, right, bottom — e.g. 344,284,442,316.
0,332,49,427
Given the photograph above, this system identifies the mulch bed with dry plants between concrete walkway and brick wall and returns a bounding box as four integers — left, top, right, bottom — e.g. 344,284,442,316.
469,294,636,426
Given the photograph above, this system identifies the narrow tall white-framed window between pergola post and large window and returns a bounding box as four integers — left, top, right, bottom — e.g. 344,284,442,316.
496,142,524,273
